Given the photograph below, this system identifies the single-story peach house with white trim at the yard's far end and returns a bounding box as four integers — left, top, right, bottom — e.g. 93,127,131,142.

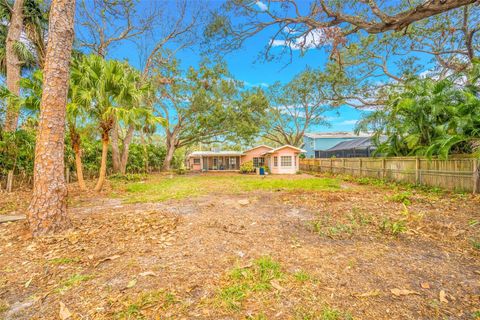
187,145,305,174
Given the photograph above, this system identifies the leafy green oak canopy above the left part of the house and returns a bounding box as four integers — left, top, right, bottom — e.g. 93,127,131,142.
153,60,268,147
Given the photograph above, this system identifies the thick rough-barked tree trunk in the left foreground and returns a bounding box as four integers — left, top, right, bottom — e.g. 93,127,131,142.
27,0,75,236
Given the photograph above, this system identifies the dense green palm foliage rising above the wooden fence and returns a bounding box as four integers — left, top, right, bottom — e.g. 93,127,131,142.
357,63,480,158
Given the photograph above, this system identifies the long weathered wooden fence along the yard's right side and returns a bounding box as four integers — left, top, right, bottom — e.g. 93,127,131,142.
300,157,480,193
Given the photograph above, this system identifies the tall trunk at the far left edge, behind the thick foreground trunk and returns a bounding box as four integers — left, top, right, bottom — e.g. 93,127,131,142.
5,0,24,132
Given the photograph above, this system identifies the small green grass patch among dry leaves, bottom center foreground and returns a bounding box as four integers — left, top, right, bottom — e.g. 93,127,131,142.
217,256,284,311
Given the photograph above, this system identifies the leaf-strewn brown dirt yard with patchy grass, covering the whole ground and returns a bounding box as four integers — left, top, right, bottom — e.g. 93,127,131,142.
0,174,480,320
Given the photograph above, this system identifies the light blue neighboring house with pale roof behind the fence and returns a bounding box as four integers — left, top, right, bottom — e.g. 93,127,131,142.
303,132,370,158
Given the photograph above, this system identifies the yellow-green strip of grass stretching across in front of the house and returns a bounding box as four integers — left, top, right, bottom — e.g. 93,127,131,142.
112,174,340,203
